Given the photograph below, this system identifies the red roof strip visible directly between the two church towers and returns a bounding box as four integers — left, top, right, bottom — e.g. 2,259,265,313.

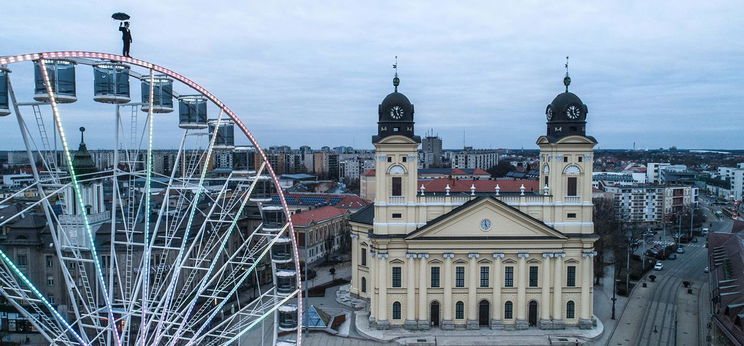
416,178,539,193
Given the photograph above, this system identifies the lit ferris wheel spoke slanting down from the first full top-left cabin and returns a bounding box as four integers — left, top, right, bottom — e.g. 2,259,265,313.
39,55,121,345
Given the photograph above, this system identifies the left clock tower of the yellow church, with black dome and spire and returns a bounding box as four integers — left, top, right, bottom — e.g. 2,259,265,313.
372,59,421,234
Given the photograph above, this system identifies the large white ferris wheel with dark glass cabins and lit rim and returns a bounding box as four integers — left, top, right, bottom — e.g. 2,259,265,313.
0,51,302,345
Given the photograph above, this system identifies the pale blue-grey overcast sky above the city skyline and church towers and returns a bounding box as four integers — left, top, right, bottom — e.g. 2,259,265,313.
0,0,744,149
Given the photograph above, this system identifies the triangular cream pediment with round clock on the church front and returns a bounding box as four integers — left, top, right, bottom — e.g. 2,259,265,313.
406,197,566,240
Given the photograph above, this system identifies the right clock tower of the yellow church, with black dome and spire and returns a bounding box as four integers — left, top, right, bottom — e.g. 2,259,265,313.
537,58,597,233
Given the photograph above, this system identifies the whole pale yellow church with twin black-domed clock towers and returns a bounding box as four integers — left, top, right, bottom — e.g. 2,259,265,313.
350,69,597,330
